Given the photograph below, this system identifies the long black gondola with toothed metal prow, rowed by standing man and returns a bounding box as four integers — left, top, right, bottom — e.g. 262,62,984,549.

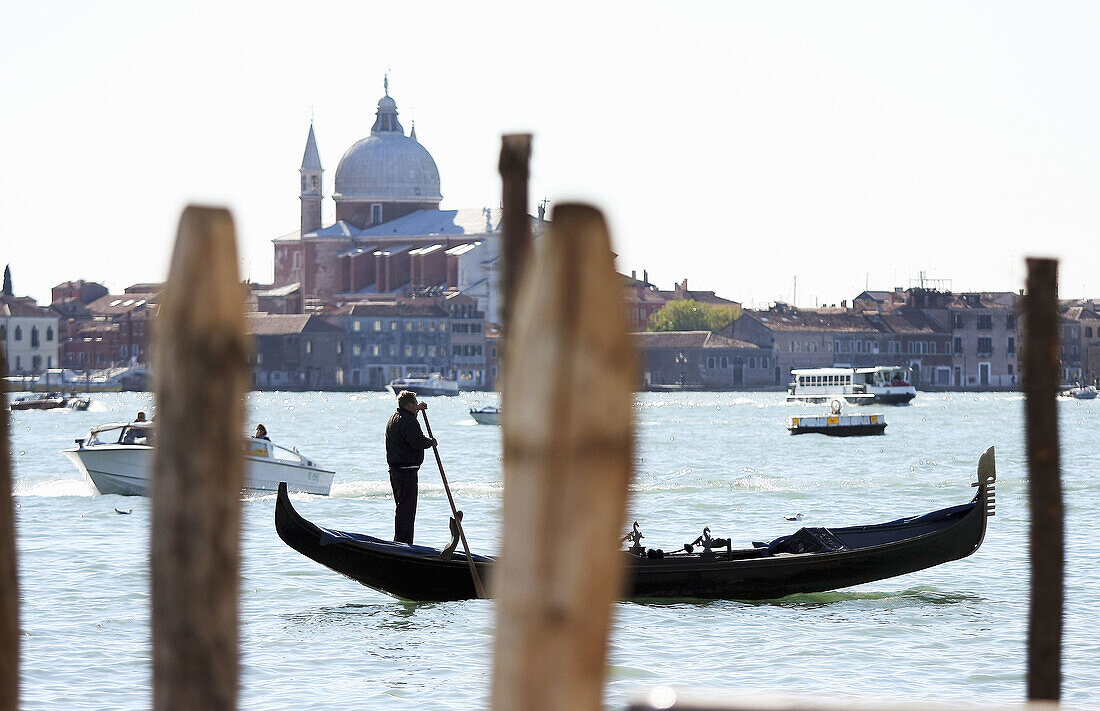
275,447,997,602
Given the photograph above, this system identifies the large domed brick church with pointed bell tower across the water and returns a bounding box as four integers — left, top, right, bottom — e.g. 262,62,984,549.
273,81,541,322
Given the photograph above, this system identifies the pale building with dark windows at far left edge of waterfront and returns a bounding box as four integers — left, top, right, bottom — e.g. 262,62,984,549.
0,269,59,375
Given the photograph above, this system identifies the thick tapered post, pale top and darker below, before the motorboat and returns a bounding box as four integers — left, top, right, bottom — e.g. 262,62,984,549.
150,206,249,711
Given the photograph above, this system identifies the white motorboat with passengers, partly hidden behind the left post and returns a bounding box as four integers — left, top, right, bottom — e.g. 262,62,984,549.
62,422,332,496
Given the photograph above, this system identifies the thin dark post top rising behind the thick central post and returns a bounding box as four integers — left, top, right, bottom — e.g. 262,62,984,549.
498,133,531,340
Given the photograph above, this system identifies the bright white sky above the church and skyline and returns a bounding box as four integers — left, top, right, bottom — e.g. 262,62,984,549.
0,0,1100,307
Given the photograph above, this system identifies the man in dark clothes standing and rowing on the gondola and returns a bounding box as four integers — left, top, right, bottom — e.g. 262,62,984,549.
386,390,436,544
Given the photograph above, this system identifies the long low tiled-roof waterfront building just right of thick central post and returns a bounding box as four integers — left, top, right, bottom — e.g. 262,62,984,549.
634,331,772,390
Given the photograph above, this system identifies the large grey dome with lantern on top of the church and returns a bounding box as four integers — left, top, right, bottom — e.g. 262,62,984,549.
333,92,443,203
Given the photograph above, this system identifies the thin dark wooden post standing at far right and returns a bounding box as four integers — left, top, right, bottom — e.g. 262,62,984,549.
1023,259,1066,701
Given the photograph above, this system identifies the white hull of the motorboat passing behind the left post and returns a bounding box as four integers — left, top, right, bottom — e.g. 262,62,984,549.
63,445,333,496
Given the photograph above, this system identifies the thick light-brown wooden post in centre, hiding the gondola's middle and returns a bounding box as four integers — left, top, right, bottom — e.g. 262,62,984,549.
492,205,636,711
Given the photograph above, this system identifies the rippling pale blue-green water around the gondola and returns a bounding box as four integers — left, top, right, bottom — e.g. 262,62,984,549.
11,393,1100,710
